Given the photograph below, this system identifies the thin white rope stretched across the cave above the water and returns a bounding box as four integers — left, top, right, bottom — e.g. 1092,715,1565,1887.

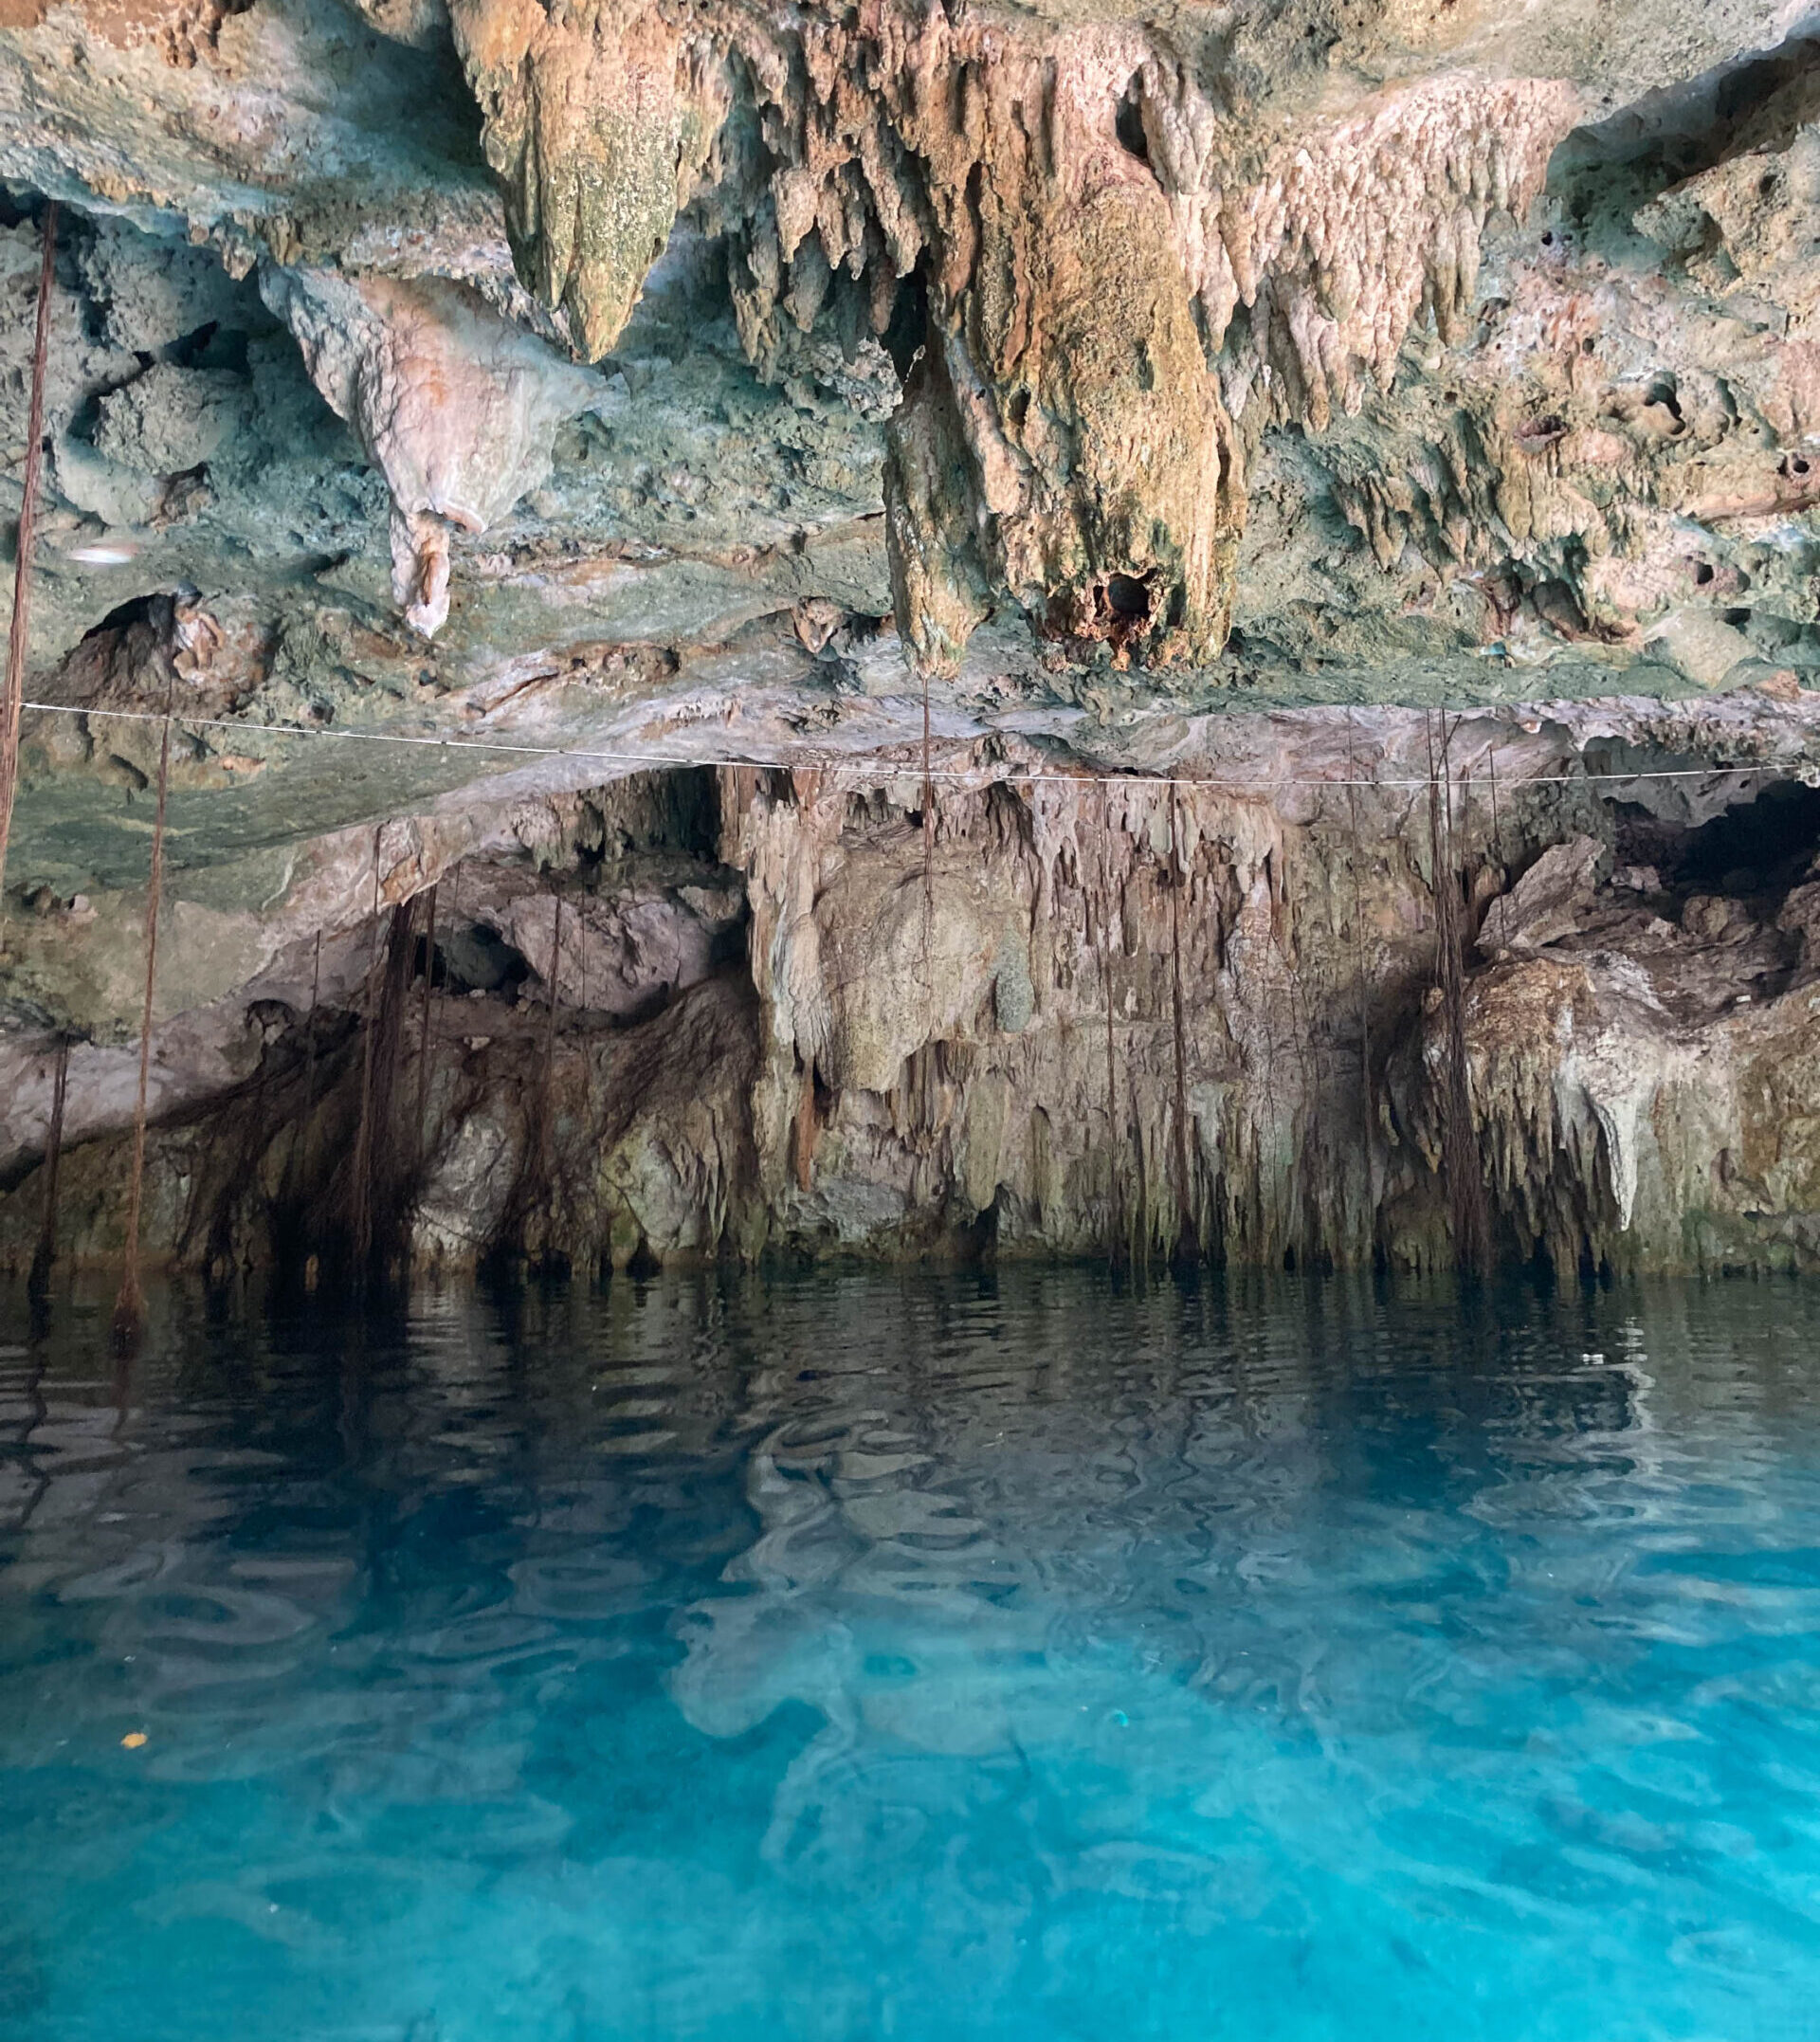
21,702,1792,793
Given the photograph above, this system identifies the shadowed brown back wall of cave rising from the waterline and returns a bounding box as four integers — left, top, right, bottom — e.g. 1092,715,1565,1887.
10,717,1820,1276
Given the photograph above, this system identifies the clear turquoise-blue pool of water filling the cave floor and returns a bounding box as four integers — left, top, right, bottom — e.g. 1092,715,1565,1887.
0,1272,1820,2042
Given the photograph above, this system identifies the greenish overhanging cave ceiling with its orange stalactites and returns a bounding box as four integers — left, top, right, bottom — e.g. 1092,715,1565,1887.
0,0,1820,904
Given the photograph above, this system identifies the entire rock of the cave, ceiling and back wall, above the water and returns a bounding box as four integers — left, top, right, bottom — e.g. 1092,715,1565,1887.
0,0,1820,1272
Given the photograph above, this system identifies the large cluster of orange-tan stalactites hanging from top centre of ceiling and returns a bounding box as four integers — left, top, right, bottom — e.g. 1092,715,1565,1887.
441,0,1579,676
